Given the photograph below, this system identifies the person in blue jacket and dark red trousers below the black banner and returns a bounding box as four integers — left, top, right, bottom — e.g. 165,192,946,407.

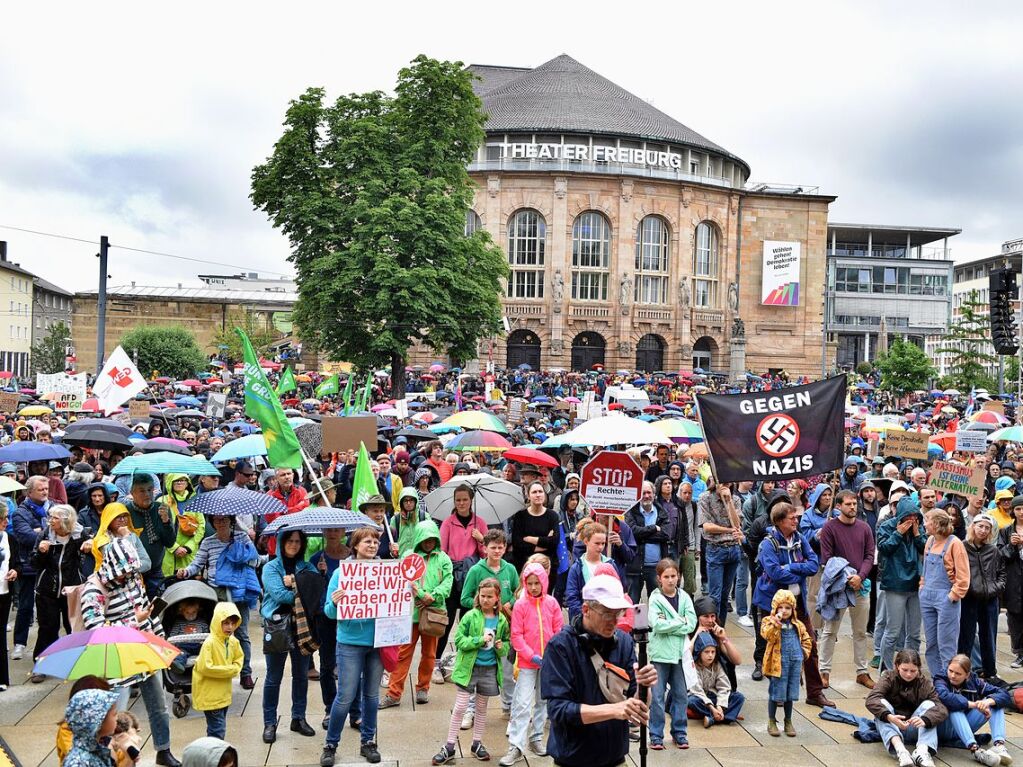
753,502,835,708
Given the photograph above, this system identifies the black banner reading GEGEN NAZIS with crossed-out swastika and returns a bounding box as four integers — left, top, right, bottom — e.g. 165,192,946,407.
697,375,846,482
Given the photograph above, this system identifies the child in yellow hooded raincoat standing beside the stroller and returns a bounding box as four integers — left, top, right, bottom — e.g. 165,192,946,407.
192,602,244,738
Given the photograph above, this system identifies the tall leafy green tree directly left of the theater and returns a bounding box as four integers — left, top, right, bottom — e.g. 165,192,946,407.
252,56,507,397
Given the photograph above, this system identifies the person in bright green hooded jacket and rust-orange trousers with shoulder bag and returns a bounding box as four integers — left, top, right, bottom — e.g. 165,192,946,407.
380,520,454,709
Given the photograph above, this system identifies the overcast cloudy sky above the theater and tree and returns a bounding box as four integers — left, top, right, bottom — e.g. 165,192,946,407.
0,0,1023,290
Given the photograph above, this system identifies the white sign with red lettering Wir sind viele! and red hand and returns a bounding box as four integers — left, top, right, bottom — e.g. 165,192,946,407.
338,556,415,621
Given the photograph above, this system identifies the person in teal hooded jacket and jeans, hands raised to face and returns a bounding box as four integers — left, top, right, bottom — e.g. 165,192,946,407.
876,495,927,670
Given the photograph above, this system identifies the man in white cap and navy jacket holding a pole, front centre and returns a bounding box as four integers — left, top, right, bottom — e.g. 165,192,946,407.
540,576,657,767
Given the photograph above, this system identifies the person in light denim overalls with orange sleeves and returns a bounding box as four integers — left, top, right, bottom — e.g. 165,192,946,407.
920,509,970,676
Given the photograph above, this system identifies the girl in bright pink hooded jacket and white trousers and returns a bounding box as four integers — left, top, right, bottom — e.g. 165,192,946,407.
500,562,563,767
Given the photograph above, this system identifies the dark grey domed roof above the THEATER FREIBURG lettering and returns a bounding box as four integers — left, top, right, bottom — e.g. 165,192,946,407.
469,54,749,172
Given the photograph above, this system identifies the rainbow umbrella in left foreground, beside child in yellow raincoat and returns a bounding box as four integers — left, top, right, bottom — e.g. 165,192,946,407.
32,626,181,679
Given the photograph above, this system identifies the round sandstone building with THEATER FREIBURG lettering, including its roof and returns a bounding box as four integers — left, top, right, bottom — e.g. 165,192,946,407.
466,55,835,375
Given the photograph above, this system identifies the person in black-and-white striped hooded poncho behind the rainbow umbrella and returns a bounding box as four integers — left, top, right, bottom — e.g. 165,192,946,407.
81,539,181,767
